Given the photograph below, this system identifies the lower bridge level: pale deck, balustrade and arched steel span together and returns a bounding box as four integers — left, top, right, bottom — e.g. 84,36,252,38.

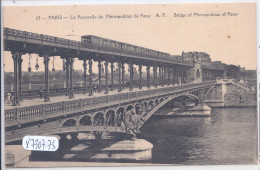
5,81,218,142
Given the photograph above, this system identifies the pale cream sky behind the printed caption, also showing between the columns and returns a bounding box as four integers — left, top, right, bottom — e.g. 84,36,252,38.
3,3,256,72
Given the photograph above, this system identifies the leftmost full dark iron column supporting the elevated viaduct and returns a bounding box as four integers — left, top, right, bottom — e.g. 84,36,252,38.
12,51,20,106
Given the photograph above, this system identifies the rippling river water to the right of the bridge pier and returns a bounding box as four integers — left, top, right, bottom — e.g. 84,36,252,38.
141,108,257,164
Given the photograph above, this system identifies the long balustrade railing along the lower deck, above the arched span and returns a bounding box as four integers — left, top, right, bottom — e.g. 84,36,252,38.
5,81,217,122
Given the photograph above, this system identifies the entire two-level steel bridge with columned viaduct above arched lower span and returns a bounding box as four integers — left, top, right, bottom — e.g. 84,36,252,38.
3,28,228,142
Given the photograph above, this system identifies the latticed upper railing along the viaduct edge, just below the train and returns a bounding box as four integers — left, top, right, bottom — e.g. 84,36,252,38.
4,28,192,65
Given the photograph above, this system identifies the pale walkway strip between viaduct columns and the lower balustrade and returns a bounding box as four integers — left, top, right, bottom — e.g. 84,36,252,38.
4,85,169,110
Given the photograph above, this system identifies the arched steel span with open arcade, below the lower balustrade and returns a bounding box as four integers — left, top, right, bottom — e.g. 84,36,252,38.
6,83,217,142
